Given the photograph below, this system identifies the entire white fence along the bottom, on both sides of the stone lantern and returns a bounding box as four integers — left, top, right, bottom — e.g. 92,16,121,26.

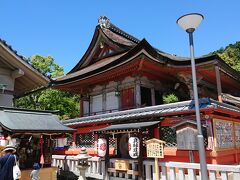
52,155,240,180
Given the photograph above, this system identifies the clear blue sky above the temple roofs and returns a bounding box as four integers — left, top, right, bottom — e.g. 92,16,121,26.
0,0,240,73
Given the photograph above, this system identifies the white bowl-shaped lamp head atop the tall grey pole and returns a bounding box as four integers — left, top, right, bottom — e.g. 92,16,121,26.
177,13,204,32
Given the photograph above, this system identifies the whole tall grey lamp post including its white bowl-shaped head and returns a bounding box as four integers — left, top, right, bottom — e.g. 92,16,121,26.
177,13,208,180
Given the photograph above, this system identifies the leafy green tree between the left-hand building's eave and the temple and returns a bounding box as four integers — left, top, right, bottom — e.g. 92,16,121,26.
15,55,80,119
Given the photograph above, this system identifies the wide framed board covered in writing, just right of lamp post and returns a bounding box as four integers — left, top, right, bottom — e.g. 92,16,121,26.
213,119,235,150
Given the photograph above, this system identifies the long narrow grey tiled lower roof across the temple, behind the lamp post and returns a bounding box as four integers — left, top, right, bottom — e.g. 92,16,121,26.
63,98,240,126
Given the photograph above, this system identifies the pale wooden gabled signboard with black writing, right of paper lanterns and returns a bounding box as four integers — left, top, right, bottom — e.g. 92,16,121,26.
146,138,165,158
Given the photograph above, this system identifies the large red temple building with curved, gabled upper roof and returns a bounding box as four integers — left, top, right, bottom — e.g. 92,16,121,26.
53,16,240,179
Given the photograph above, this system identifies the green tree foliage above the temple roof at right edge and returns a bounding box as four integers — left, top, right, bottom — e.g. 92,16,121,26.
211,42,240,71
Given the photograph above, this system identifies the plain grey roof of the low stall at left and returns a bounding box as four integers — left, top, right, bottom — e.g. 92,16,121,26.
0,107,74,133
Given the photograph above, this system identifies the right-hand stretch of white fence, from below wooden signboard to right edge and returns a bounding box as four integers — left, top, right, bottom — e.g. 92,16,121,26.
143,161,240,180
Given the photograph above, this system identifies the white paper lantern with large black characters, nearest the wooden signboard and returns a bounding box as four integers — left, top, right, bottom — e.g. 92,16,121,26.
128,137,140,158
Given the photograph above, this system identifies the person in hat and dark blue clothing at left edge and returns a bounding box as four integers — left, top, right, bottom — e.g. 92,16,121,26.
0,145,16,180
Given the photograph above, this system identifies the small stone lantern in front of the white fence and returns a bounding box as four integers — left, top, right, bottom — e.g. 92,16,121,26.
75,148,92,180
